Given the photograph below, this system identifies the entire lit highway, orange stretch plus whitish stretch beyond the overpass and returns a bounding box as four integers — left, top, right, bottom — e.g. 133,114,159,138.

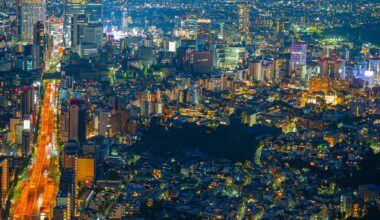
11,16,63,219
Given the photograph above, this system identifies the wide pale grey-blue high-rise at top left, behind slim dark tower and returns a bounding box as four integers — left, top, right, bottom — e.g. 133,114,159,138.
17,0,46,42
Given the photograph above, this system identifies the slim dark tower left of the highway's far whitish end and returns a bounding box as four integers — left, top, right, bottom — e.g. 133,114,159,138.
33,21,46,67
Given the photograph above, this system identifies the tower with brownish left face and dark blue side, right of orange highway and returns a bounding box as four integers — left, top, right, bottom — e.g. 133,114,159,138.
69,99,86,145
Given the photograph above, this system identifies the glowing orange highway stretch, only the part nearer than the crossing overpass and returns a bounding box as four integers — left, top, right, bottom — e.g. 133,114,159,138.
13,81,59,219
